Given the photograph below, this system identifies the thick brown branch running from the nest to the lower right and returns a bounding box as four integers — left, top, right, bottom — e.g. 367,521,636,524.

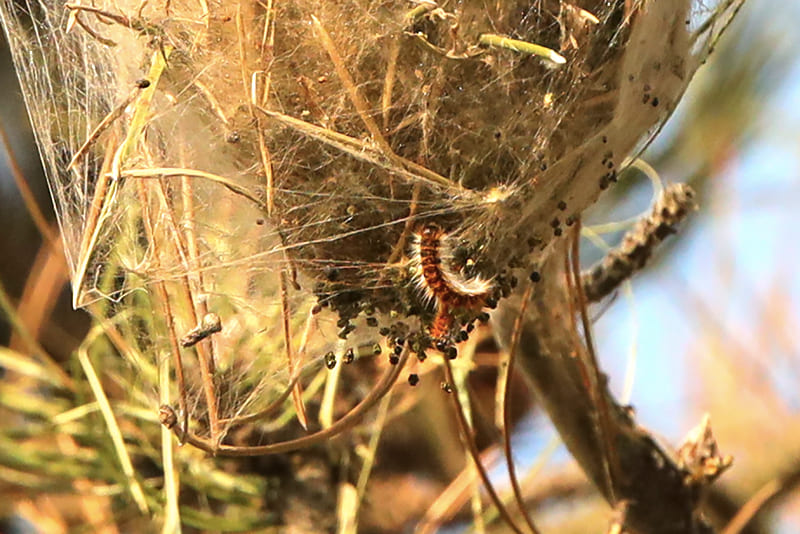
493,250,713,534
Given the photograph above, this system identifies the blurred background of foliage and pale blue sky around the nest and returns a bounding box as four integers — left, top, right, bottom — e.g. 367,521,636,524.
0,0,800,534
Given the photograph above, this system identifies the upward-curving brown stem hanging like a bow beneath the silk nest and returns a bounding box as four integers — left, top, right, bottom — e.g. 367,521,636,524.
166,348,409,456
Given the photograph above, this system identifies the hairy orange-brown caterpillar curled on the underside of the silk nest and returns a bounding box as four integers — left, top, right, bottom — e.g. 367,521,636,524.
411,223,492,340
